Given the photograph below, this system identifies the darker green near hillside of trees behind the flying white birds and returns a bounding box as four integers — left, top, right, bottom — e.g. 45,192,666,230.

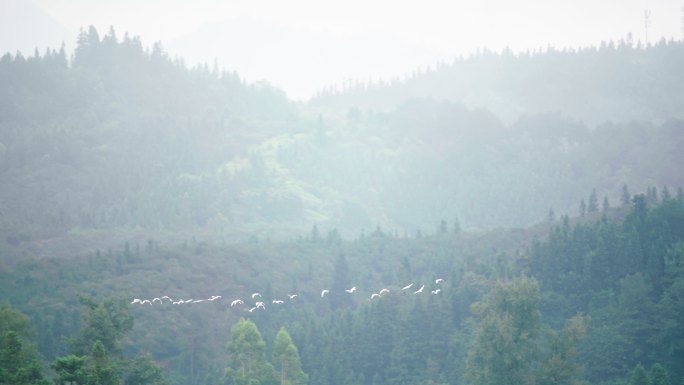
0,190,684,385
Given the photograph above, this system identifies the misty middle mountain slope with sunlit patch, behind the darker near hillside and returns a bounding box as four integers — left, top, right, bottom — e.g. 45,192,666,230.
0,28,684,250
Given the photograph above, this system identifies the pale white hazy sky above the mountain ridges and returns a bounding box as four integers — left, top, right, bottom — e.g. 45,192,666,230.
5,0,684,98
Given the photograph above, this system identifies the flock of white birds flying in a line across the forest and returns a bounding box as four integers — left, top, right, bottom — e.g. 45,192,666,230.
131,278,444,313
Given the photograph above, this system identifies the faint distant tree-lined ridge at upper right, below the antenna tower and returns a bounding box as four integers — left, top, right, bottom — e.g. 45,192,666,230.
310,41,684,126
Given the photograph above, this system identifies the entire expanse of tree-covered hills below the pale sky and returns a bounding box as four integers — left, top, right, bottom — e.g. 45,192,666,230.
0,27,684,385
